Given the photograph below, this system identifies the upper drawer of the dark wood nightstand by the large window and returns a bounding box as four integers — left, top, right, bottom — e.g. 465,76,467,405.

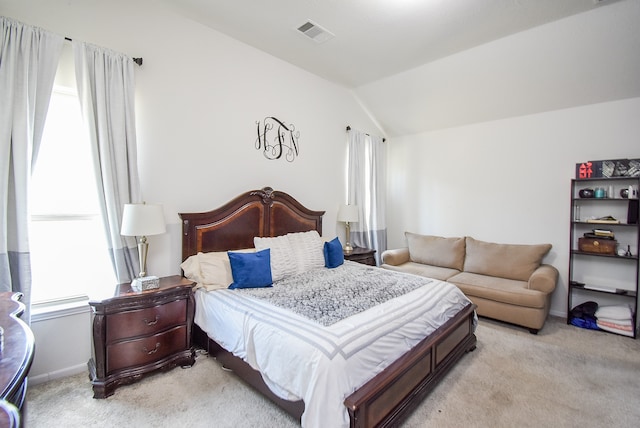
107,299,187,343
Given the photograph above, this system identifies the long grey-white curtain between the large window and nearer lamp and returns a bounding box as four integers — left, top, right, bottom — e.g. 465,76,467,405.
73,41,140,283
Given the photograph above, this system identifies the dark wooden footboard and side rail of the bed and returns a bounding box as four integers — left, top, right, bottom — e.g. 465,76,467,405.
193,304,476,428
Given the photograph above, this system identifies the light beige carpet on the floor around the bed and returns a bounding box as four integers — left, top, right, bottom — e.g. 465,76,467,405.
25,317,640,428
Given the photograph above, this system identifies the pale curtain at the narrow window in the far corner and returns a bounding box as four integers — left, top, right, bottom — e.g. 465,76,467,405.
347,129,387,265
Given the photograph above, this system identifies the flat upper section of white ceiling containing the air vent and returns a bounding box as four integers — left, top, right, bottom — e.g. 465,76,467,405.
159,0,612,87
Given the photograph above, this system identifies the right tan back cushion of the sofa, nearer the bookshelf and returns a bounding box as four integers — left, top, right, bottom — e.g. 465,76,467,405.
464,236,551,281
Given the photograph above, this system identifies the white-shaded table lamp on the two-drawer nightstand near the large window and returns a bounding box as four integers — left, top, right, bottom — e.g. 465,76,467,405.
120,202,166,291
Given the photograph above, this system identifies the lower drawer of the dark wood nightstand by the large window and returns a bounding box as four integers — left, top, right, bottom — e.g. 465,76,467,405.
107,325,187,373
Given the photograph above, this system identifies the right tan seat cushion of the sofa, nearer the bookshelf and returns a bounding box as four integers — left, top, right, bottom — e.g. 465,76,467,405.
447,272,547,309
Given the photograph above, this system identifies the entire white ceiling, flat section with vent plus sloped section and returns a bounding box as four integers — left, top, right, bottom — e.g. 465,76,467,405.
159,0,640,137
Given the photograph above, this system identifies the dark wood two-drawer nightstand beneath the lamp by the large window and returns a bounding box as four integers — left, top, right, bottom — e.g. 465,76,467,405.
88,275,195,398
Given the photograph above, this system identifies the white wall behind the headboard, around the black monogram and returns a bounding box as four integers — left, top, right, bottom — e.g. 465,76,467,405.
0,0,379,379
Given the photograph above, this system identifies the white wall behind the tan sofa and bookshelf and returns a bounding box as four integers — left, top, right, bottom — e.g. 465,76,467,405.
387,98,640,315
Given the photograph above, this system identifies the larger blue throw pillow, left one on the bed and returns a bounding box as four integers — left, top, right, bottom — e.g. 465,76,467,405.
227,248,273,289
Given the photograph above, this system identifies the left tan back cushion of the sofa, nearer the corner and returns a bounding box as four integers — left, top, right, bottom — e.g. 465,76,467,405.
404,232,464,270
